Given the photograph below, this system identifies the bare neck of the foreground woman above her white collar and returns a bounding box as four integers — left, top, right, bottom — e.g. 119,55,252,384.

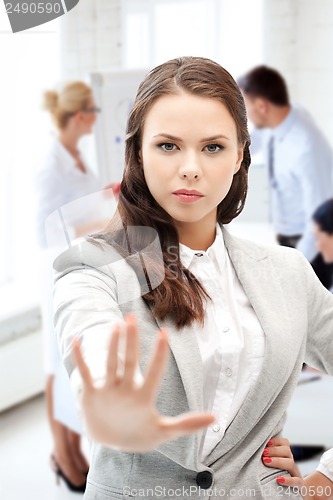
175,219,216,251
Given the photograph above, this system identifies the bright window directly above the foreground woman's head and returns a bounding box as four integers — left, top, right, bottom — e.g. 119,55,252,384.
122,0,263,78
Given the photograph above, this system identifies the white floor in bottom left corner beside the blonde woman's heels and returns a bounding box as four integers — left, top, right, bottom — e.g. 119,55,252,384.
0,396,88,500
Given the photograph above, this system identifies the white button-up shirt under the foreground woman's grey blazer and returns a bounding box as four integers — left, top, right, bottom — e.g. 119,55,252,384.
180,225,265,460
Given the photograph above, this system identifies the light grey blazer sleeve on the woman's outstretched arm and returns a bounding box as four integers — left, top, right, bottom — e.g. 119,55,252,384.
54,240,141,393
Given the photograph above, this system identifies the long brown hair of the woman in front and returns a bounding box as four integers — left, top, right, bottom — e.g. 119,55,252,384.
98,57,251,327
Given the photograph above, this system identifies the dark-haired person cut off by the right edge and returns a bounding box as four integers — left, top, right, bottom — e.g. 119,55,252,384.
312,198,333,293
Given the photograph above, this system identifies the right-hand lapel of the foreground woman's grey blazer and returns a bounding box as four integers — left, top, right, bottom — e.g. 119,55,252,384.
207,229,290,463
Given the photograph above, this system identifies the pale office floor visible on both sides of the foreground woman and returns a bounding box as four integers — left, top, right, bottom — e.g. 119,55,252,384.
0,377,333,500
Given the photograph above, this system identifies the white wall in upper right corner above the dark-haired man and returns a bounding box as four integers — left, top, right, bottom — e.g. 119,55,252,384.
264,0,333,145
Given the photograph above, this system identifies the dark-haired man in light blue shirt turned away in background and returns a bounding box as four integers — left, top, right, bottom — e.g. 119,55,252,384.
238,66,333,288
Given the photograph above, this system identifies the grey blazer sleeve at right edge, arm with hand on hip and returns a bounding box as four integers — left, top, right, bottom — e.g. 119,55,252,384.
301,252,333,375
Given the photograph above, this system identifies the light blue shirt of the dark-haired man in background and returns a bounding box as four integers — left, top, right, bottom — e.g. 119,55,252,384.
250,107,333,261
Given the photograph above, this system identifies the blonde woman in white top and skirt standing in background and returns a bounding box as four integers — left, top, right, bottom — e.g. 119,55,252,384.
37,81,117,492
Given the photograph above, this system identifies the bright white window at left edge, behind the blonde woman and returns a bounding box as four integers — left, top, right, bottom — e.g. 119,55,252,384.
0,11,60,292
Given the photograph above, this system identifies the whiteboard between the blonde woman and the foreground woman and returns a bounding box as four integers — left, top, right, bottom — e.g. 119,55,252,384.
90,69,149,185
